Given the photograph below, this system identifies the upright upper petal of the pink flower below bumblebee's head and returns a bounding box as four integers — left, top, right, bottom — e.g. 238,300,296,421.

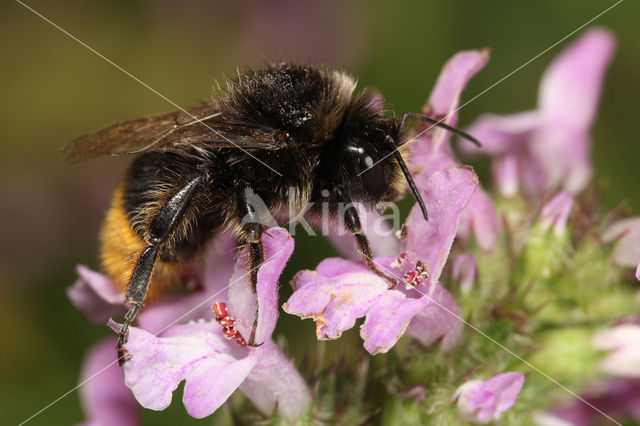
404,166,478,283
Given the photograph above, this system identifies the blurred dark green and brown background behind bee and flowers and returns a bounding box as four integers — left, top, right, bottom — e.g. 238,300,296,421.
0,0,640,424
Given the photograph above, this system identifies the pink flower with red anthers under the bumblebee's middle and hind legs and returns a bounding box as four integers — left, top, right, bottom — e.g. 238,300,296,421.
117,228,310,420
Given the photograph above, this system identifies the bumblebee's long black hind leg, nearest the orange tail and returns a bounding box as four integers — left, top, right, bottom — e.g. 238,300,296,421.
117,175,205,366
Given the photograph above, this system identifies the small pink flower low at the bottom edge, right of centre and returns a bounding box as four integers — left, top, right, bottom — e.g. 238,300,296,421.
454,371,524,423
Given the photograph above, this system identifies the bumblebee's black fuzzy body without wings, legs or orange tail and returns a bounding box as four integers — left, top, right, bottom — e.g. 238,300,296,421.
117,64,399,261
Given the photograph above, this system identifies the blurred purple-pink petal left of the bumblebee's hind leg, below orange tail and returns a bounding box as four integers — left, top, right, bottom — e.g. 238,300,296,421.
67,265,127,324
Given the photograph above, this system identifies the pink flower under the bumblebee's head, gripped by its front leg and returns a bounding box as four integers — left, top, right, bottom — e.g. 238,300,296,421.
283,167,478,354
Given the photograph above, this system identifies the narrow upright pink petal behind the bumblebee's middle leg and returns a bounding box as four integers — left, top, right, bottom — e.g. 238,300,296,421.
227,228,294,343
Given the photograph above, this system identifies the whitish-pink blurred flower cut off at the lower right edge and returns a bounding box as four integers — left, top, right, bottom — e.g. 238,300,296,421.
593,324,640,378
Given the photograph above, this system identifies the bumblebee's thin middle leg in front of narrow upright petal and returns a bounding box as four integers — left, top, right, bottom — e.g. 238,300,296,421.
241,187,264,346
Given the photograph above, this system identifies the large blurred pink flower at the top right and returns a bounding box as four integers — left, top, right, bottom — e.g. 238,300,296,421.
462,29,615,197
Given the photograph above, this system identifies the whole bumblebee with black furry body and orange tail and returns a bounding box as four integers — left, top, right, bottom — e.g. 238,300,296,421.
63,63,474,365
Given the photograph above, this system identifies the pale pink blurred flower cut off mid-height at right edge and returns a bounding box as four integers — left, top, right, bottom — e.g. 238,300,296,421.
602,217,640,281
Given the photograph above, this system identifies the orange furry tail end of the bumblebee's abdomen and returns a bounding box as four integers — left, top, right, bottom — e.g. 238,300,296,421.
100,184,191,300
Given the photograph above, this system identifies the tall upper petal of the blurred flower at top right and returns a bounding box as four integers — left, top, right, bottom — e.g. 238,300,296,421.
538,28,616,130
